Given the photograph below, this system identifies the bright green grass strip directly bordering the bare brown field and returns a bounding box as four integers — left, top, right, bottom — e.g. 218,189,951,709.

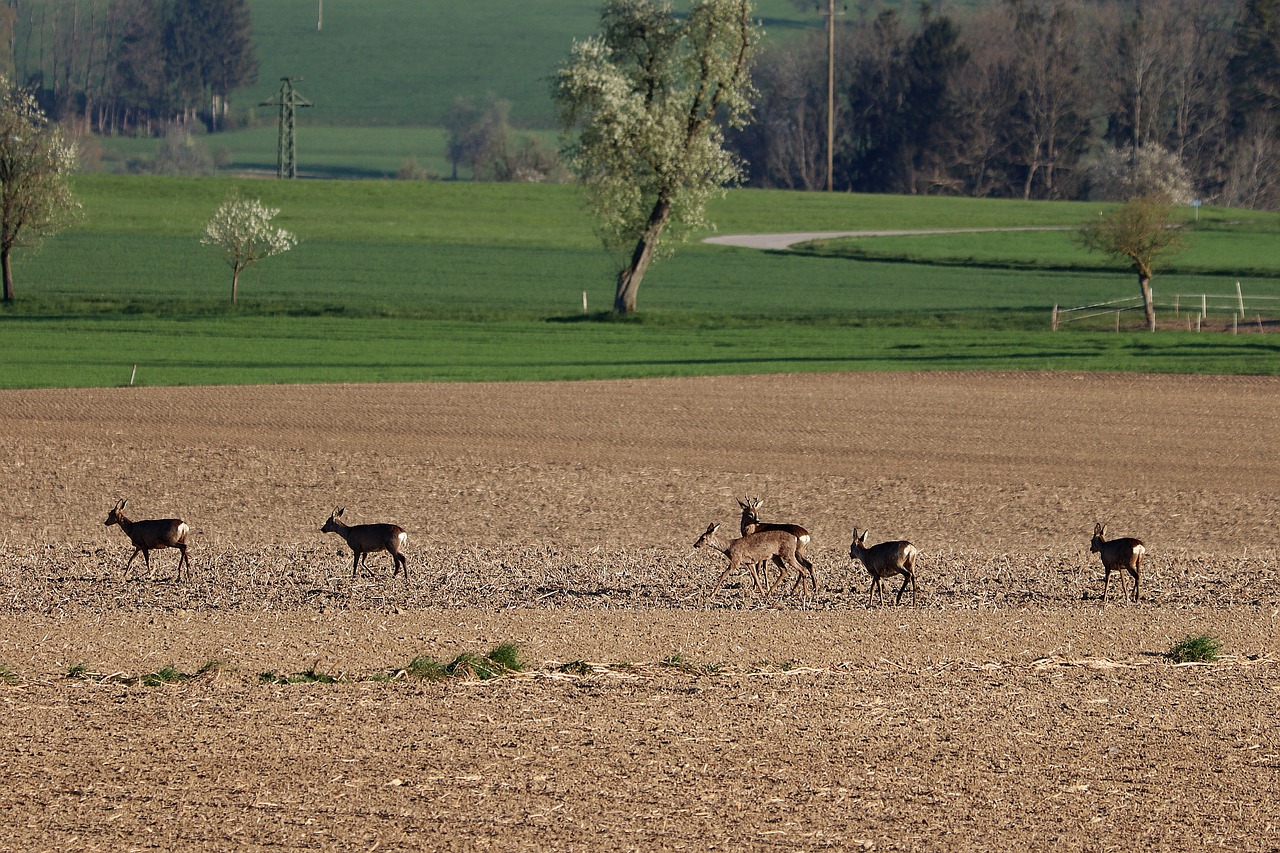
4,316,1280,388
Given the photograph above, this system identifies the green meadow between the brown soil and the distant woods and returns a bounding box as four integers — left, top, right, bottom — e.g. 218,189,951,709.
0,175,1280,388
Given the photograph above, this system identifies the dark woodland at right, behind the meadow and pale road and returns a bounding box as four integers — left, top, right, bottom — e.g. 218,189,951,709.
730,0,1280,209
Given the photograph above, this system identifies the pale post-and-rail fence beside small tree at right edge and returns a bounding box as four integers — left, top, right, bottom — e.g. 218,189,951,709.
1051,282,1280,333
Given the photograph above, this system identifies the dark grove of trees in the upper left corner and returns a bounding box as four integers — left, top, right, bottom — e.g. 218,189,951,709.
0,0,259,133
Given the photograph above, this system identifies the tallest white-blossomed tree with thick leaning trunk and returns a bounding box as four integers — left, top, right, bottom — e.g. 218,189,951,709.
556,0,760,314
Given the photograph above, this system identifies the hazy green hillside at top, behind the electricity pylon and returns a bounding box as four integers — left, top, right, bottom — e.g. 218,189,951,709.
237,0,822,128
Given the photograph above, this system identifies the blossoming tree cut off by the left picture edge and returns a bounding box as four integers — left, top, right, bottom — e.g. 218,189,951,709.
0,76,79,302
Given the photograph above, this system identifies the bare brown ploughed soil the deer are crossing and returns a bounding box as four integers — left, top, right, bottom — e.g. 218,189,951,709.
0,373,1280,850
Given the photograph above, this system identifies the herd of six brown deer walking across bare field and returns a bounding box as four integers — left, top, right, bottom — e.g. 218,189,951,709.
105,497,1147,607
